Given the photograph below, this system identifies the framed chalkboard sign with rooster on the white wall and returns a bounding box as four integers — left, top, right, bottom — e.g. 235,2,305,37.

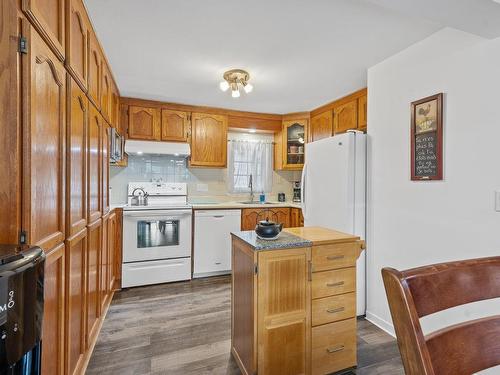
411,93,443,181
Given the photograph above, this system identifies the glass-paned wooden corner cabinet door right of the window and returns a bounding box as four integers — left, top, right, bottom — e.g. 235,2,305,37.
283,120,306,169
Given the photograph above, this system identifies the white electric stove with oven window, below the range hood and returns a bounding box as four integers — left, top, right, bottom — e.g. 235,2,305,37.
122,182,192,288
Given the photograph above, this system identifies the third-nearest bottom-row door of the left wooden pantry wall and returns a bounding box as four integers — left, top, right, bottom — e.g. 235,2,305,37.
86,219,102,347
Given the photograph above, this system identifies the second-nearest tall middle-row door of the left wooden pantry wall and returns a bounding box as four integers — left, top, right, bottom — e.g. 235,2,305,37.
66,75,88,237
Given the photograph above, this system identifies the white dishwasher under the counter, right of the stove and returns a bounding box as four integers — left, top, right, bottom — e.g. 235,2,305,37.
193,210,241,277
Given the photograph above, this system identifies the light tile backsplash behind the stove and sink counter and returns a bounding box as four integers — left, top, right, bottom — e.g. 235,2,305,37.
110,155,301,204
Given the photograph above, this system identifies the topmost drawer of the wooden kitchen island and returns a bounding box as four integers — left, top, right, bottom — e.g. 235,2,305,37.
312,243,359,272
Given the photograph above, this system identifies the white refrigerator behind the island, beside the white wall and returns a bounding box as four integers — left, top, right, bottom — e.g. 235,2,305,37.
301,131,366,315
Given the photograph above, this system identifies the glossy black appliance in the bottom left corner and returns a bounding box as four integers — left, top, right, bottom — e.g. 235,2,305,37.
0,245,45,375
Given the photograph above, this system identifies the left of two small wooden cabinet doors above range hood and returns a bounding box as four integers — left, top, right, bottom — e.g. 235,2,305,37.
128,106,160,141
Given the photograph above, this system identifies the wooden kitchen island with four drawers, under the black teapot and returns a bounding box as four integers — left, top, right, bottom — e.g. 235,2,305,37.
231,227,364,375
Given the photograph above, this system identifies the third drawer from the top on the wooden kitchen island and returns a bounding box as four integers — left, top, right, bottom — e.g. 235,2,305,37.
312,293,356,326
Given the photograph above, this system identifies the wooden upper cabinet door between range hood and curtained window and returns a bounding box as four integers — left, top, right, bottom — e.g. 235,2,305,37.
189,113,227,168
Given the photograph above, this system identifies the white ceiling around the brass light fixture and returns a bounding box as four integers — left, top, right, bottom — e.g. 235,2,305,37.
85,0,500,113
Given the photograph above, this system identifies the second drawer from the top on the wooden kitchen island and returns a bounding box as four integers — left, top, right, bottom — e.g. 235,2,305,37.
312,267,356,298
